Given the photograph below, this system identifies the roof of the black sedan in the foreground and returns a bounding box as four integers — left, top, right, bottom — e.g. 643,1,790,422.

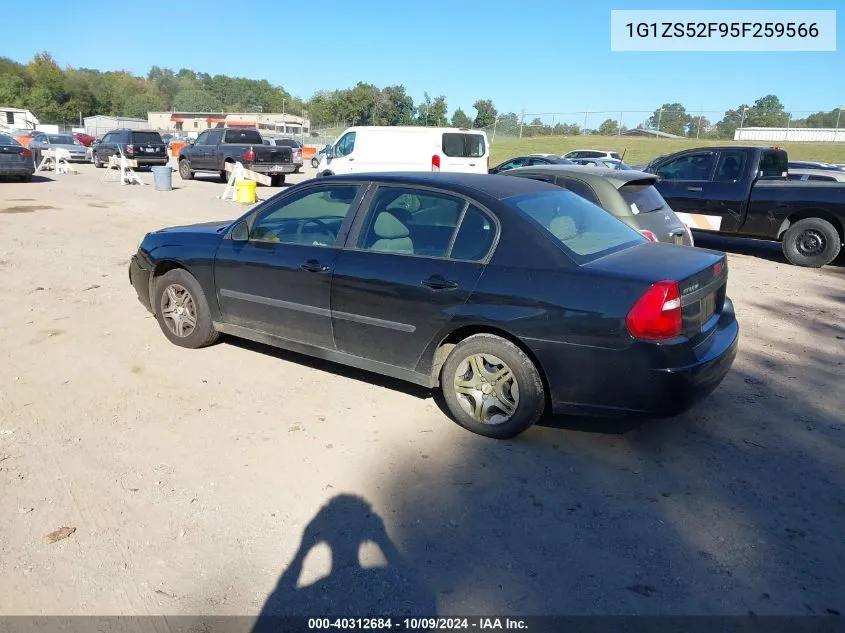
321,172,559,200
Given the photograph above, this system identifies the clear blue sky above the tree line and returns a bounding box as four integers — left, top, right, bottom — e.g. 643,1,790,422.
0,0,845,125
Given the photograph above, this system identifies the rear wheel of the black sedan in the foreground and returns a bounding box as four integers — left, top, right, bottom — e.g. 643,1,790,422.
440,334,546,439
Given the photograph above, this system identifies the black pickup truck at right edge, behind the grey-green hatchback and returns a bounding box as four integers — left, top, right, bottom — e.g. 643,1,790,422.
645,145,845,268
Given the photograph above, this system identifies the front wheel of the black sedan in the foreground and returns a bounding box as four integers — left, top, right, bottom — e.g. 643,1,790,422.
152,268,220,349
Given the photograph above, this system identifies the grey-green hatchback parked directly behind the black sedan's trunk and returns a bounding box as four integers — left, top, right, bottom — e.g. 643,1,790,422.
506,165,694,246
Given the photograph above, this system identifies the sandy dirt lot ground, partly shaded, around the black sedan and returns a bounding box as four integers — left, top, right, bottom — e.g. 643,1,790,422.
0,160,845,617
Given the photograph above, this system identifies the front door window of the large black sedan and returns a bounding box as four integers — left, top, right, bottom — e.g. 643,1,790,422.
249,185,360,246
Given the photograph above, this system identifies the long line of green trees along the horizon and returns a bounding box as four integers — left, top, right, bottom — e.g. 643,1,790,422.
0,53,845,138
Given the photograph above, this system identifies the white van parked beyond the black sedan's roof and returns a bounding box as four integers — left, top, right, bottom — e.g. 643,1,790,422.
317,126,490,176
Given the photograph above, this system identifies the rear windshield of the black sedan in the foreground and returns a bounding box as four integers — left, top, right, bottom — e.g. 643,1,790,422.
505,189,645,264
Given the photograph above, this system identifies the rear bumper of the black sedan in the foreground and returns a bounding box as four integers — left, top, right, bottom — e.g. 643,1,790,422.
532,298,739,418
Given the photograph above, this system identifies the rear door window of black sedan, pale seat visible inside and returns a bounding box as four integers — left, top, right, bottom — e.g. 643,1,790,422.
358,187,466,257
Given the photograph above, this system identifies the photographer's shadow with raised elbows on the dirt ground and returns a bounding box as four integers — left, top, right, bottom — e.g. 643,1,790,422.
252,495,437,633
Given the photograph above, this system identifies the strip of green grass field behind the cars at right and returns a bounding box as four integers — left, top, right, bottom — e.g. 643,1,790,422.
490,136,845,167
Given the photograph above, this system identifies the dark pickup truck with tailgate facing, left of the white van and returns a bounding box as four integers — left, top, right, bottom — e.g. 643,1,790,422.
179,128,296,187
